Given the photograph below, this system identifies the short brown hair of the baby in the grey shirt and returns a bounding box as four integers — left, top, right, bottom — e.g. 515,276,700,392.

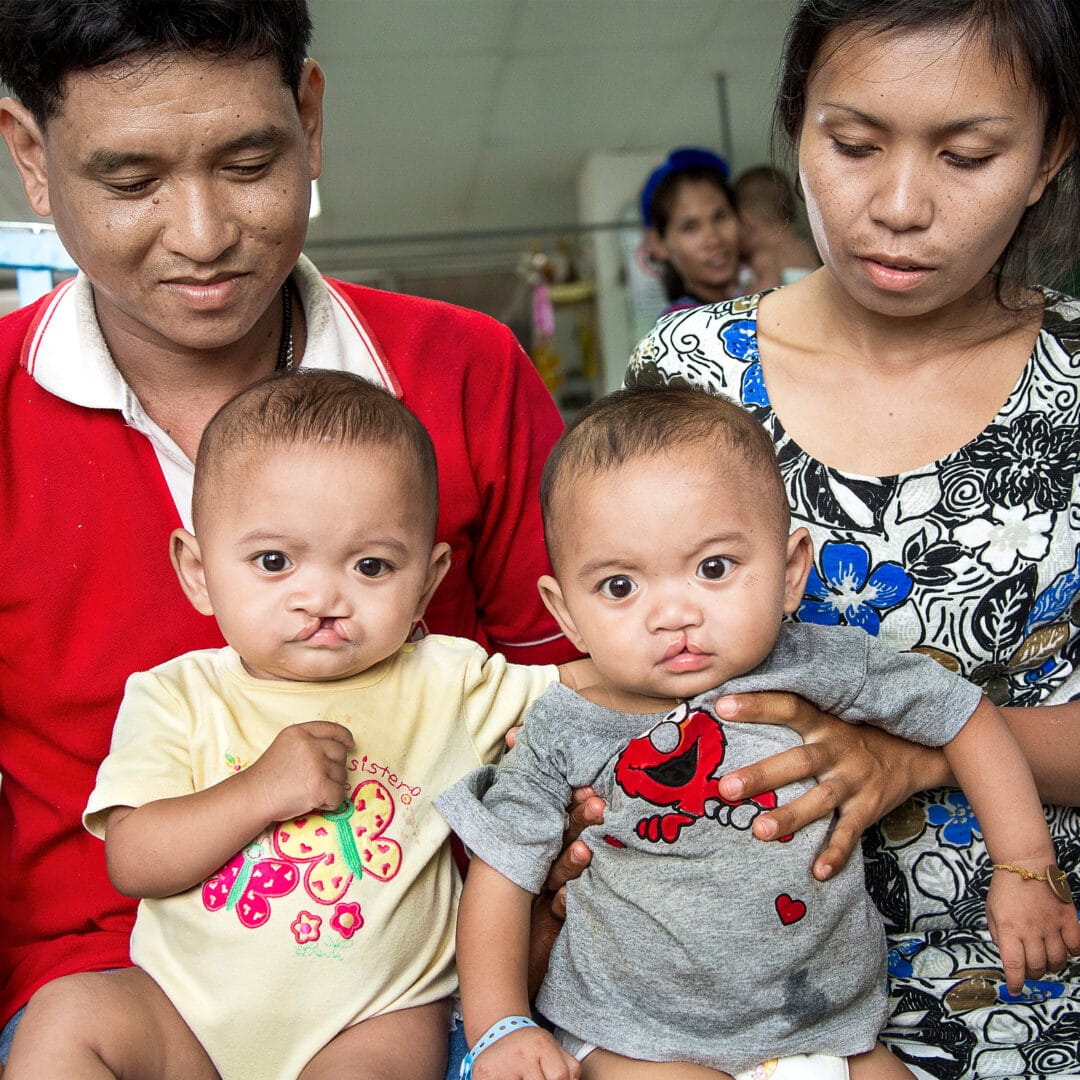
540,386,791,561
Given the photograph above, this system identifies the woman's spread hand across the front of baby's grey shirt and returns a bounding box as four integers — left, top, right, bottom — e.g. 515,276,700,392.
713,691,951,881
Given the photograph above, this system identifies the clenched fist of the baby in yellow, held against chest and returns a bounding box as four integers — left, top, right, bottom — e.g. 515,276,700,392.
245,720,352,822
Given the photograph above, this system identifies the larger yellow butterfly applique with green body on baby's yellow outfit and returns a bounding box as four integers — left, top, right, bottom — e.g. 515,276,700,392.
273,780,402,904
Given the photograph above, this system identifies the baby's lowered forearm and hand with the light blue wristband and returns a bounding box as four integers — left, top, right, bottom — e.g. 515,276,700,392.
458,858,581,1080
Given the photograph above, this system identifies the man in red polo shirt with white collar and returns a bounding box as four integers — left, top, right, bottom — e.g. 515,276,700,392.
0,0,576,1067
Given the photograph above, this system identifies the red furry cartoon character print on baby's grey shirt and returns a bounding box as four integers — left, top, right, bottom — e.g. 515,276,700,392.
615,704,787,843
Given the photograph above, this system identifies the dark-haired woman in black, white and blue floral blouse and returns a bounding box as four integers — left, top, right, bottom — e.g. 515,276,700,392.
626,0,1080,1078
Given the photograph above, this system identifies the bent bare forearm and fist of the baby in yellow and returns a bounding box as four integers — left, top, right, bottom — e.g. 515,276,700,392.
105,720,352,897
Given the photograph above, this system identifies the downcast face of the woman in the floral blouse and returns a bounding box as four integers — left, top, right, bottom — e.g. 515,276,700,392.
799,28,1064,315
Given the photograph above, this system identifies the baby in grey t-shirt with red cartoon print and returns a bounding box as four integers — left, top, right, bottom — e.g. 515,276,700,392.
436,388,1080,1080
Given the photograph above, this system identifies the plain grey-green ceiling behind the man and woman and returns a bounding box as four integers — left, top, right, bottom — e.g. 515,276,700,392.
0,0,792,278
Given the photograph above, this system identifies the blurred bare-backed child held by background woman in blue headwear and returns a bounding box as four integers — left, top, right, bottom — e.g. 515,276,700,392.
734,165,821,293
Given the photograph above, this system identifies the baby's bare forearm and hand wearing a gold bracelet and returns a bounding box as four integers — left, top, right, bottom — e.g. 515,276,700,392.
944,698,1080,994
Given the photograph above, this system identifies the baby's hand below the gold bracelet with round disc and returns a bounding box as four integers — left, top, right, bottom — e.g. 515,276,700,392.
986,864,1080,994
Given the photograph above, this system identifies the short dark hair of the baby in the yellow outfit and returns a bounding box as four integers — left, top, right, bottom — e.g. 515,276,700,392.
191,370,438,537
